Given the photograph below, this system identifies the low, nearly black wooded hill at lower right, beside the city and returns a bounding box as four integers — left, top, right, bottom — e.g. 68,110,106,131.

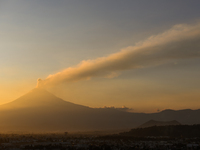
120,124,200,137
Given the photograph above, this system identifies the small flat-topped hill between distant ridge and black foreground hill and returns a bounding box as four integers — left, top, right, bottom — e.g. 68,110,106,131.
138,120,181,128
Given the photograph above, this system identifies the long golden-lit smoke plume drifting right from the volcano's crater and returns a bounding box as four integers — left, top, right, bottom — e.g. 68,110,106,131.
38,23,200,87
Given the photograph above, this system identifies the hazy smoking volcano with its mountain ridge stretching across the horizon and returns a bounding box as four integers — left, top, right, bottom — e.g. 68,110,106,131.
0,88,200,132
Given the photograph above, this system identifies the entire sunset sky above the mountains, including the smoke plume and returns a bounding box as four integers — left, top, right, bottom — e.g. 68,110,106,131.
0,0,200,112
